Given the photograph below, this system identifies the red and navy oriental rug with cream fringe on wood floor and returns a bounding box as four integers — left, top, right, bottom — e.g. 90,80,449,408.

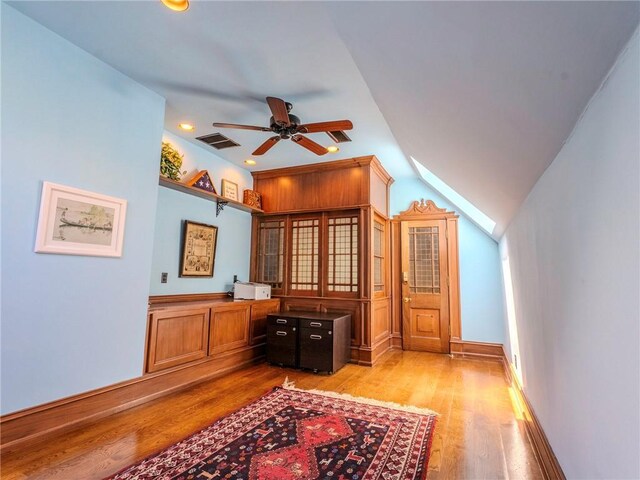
109,381,437,480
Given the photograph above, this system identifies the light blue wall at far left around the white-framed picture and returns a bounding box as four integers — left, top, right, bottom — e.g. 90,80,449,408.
1,3,164,413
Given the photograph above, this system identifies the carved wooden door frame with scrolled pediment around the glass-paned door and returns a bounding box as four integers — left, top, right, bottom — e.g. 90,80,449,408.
391,199,462,352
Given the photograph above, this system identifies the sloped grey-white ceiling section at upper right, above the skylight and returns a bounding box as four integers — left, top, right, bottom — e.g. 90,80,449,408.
331,2,640,237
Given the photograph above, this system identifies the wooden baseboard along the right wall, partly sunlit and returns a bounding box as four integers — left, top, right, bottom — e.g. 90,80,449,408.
502,347,567,480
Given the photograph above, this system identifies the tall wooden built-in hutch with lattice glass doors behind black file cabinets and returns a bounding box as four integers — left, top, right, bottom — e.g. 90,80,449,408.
250,156,393,365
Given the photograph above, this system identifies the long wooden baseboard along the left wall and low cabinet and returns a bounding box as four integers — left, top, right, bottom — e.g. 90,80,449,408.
0,345,265,452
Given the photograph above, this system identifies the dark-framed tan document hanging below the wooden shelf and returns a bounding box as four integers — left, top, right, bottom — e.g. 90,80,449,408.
179,220,218,277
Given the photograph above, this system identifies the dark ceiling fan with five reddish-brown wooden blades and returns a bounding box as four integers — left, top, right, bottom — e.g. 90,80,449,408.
213,97,353,155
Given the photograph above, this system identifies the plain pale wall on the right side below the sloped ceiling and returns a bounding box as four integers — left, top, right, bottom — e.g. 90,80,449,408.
501,31,640,479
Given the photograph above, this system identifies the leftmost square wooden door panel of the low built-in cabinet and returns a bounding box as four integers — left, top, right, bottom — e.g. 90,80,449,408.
147,308,209,372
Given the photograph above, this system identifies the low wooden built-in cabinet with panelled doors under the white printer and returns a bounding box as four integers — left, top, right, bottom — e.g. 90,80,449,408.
145,295,280,373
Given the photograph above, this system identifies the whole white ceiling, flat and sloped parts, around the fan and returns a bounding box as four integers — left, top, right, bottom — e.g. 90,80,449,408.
7,0,640,238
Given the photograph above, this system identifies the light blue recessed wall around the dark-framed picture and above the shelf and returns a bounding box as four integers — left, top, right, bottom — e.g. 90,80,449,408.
150,132,253,295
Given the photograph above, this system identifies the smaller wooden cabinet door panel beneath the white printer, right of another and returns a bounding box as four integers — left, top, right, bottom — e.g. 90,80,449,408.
209,305,251,355
